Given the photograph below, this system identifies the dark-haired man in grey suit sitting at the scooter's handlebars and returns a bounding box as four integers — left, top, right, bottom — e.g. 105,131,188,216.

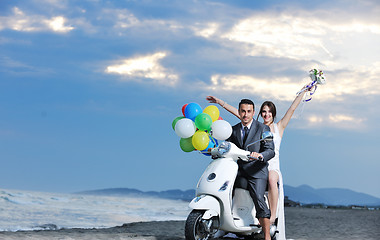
227,99,275,239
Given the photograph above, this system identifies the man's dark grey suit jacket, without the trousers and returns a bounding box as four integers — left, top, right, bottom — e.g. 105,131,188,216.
227,120,275,178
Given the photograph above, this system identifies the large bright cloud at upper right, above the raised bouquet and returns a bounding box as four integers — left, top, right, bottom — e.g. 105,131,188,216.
180,6,380,70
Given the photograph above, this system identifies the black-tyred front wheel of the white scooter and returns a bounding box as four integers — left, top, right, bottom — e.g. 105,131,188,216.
185,210,219,240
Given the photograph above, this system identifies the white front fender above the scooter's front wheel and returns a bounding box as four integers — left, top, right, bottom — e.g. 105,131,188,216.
189,195,220,219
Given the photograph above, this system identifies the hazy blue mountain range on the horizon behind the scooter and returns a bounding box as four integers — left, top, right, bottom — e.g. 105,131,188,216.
78,185,380,206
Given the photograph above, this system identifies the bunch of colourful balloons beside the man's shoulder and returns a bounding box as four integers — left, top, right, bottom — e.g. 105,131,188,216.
172,103,232,155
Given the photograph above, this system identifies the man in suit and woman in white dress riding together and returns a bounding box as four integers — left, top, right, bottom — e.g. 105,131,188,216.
206,81,312,239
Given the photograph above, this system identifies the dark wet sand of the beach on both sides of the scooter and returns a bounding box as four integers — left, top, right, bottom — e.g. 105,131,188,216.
0,208,380,240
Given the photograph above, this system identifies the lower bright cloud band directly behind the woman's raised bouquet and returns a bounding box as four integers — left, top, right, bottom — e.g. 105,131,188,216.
209,62,380,102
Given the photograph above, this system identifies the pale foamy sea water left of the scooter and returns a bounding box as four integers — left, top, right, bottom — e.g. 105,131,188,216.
0,189,190,231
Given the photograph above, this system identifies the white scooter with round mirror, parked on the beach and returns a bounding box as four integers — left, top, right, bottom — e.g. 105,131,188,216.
185,132,278,240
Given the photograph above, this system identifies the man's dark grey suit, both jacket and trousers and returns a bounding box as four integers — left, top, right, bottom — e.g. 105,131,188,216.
227,120,275,218
